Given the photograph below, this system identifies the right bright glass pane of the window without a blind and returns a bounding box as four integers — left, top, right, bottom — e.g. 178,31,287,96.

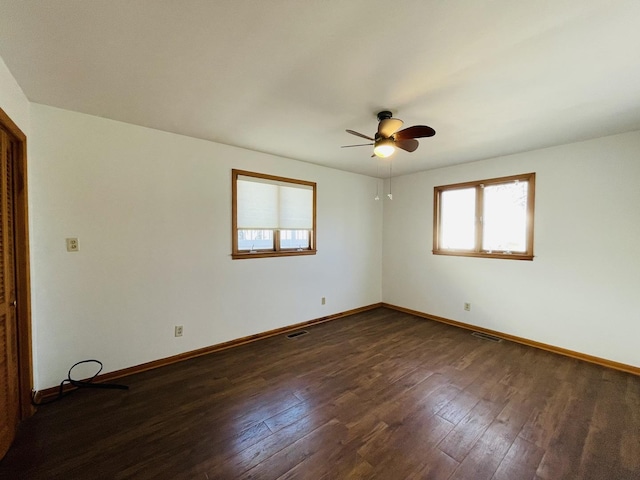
482,181,529,252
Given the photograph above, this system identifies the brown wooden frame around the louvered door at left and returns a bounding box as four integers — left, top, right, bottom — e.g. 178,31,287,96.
0,108,35,420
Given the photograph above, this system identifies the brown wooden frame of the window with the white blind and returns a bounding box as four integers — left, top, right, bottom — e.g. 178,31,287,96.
231,169,317,260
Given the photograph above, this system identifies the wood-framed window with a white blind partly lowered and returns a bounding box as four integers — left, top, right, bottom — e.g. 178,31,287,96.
231,170,316,259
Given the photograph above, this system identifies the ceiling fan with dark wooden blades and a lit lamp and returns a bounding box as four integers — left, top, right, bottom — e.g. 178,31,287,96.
342,110,436,158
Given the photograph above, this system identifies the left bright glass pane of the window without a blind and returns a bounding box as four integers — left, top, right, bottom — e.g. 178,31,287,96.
440,188,476,250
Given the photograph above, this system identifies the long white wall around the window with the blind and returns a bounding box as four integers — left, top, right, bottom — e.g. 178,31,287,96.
29,104,382,389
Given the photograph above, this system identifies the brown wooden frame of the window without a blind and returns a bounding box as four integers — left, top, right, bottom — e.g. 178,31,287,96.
432,173,536,260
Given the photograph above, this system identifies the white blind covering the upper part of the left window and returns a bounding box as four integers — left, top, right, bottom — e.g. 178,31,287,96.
237,175,313,230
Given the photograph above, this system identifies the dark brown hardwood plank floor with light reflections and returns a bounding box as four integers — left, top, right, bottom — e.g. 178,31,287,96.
0,308,640,480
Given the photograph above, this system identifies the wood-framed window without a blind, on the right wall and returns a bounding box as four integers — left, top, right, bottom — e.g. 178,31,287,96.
433,173,536,260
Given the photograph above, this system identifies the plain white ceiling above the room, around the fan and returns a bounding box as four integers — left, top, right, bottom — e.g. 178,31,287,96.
0,0,640,177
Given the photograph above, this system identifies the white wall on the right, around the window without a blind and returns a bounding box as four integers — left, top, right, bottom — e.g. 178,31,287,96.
383,132,640,366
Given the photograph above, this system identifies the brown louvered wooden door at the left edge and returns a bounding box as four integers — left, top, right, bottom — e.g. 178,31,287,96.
0,129,20,458
